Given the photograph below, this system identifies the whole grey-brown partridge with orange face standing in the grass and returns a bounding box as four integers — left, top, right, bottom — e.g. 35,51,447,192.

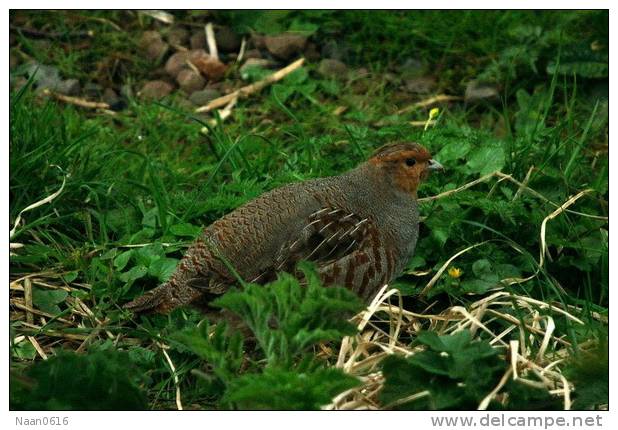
124,142,444,314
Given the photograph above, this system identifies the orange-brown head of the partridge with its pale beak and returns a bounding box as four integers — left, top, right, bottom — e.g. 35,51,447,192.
368,143,444,196
